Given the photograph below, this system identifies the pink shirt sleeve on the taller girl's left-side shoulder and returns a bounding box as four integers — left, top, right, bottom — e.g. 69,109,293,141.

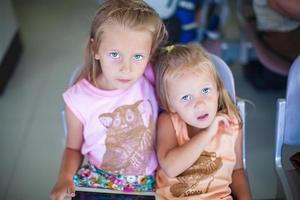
62,84,85,124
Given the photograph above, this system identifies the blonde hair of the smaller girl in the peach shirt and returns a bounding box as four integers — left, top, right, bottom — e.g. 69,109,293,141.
155,44,242,127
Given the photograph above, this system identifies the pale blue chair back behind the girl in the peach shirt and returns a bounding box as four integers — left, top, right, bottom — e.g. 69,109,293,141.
210,54,247,172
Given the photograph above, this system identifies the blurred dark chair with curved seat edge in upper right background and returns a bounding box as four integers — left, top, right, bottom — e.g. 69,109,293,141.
236,0,290,75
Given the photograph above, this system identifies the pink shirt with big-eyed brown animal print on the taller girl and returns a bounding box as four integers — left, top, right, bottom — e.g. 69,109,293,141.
63,77,158,175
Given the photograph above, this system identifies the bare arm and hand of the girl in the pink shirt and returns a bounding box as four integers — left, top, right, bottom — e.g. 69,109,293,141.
50,106,83,200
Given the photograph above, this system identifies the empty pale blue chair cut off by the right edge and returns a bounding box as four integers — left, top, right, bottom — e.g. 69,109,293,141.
275,55,300,199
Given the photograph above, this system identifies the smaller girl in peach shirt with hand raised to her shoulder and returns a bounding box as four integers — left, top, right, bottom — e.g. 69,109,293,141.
156,45,251,200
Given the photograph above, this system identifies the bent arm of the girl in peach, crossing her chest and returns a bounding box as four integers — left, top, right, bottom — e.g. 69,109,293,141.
157,112,226,177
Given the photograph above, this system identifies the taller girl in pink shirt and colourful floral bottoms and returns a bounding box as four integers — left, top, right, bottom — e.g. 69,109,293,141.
51,0,166,199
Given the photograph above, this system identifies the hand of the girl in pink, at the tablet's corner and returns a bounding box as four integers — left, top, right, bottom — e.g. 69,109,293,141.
50,180,75,200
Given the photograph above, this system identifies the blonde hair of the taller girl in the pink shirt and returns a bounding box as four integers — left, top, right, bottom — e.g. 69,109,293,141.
75,0,167,85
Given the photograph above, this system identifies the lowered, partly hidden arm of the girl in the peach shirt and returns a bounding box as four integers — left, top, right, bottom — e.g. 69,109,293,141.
230,131,252,200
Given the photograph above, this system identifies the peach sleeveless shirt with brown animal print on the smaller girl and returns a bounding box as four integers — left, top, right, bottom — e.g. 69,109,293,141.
156,114,239,200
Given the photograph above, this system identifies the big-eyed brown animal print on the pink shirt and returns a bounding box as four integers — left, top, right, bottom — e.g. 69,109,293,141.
99,100,155,175
